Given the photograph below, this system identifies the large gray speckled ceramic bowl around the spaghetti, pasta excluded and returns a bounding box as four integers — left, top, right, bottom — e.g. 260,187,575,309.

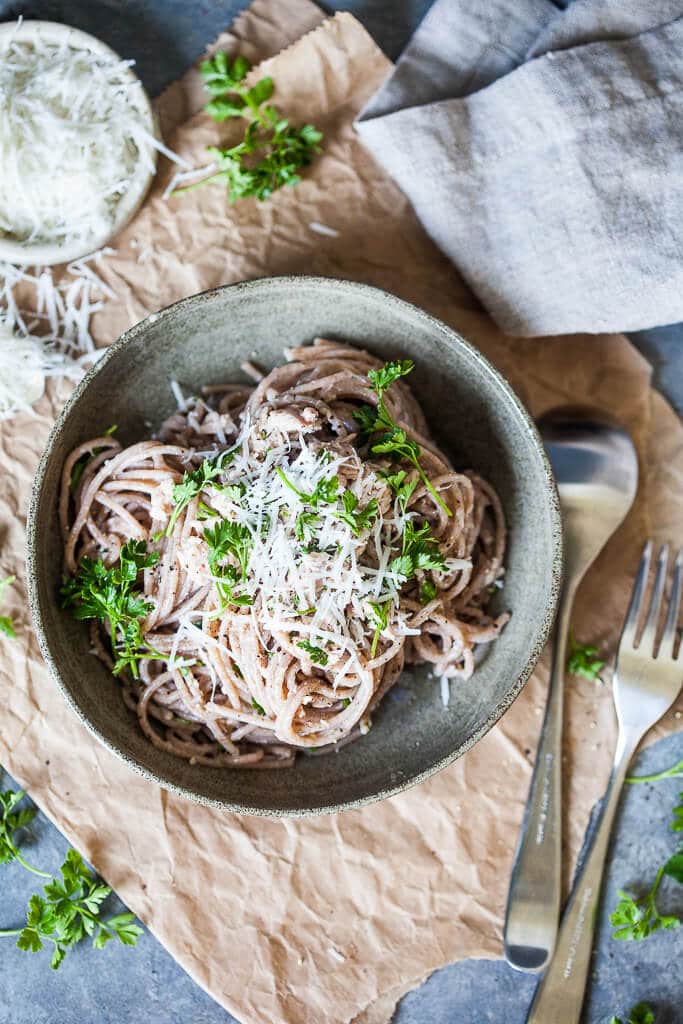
28,278,561,815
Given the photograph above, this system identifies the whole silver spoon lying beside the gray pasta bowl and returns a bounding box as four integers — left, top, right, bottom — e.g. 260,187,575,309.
505,408,638,971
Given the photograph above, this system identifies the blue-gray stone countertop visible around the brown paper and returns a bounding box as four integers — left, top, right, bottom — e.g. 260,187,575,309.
0,0,683,1024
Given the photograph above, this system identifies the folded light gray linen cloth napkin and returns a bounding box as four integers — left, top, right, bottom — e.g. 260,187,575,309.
356,0,683,336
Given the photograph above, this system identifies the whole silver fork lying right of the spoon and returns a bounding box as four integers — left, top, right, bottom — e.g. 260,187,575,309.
526,541,683,1024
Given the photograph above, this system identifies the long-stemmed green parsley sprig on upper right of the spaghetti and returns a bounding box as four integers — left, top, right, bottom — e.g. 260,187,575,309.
353,359,453,516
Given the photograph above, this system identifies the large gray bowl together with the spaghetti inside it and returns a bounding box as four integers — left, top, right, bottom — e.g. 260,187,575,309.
29,278,561,814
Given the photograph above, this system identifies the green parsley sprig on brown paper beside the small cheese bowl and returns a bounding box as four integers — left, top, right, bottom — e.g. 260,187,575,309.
177,52,323,203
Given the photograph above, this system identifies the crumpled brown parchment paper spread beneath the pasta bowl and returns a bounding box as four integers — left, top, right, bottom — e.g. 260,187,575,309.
0,0,683,1024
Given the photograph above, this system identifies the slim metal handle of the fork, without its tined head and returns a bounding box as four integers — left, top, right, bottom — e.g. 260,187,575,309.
526,731,641,1024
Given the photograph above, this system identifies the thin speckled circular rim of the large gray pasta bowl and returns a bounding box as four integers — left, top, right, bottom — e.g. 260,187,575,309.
27,274,563,818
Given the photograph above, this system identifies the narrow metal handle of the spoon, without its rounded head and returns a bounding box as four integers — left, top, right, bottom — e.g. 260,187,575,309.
505,584,574,971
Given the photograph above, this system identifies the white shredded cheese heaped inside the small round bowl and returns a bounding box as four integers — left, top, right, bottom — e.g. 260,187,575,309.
0,23,180,252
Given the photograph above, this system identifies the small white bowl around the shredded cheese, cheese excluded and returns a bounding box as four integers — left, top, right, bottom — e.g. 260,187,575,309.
0,22,161,266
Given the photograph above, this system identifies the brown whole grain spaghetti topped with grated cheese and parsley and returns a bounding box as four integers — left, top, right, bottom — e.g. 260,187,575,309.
59,339,508,767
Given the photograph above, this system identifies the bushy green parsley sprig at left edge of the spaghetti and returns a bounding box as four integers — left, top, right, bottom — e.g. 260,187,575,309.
59,540,159,678
